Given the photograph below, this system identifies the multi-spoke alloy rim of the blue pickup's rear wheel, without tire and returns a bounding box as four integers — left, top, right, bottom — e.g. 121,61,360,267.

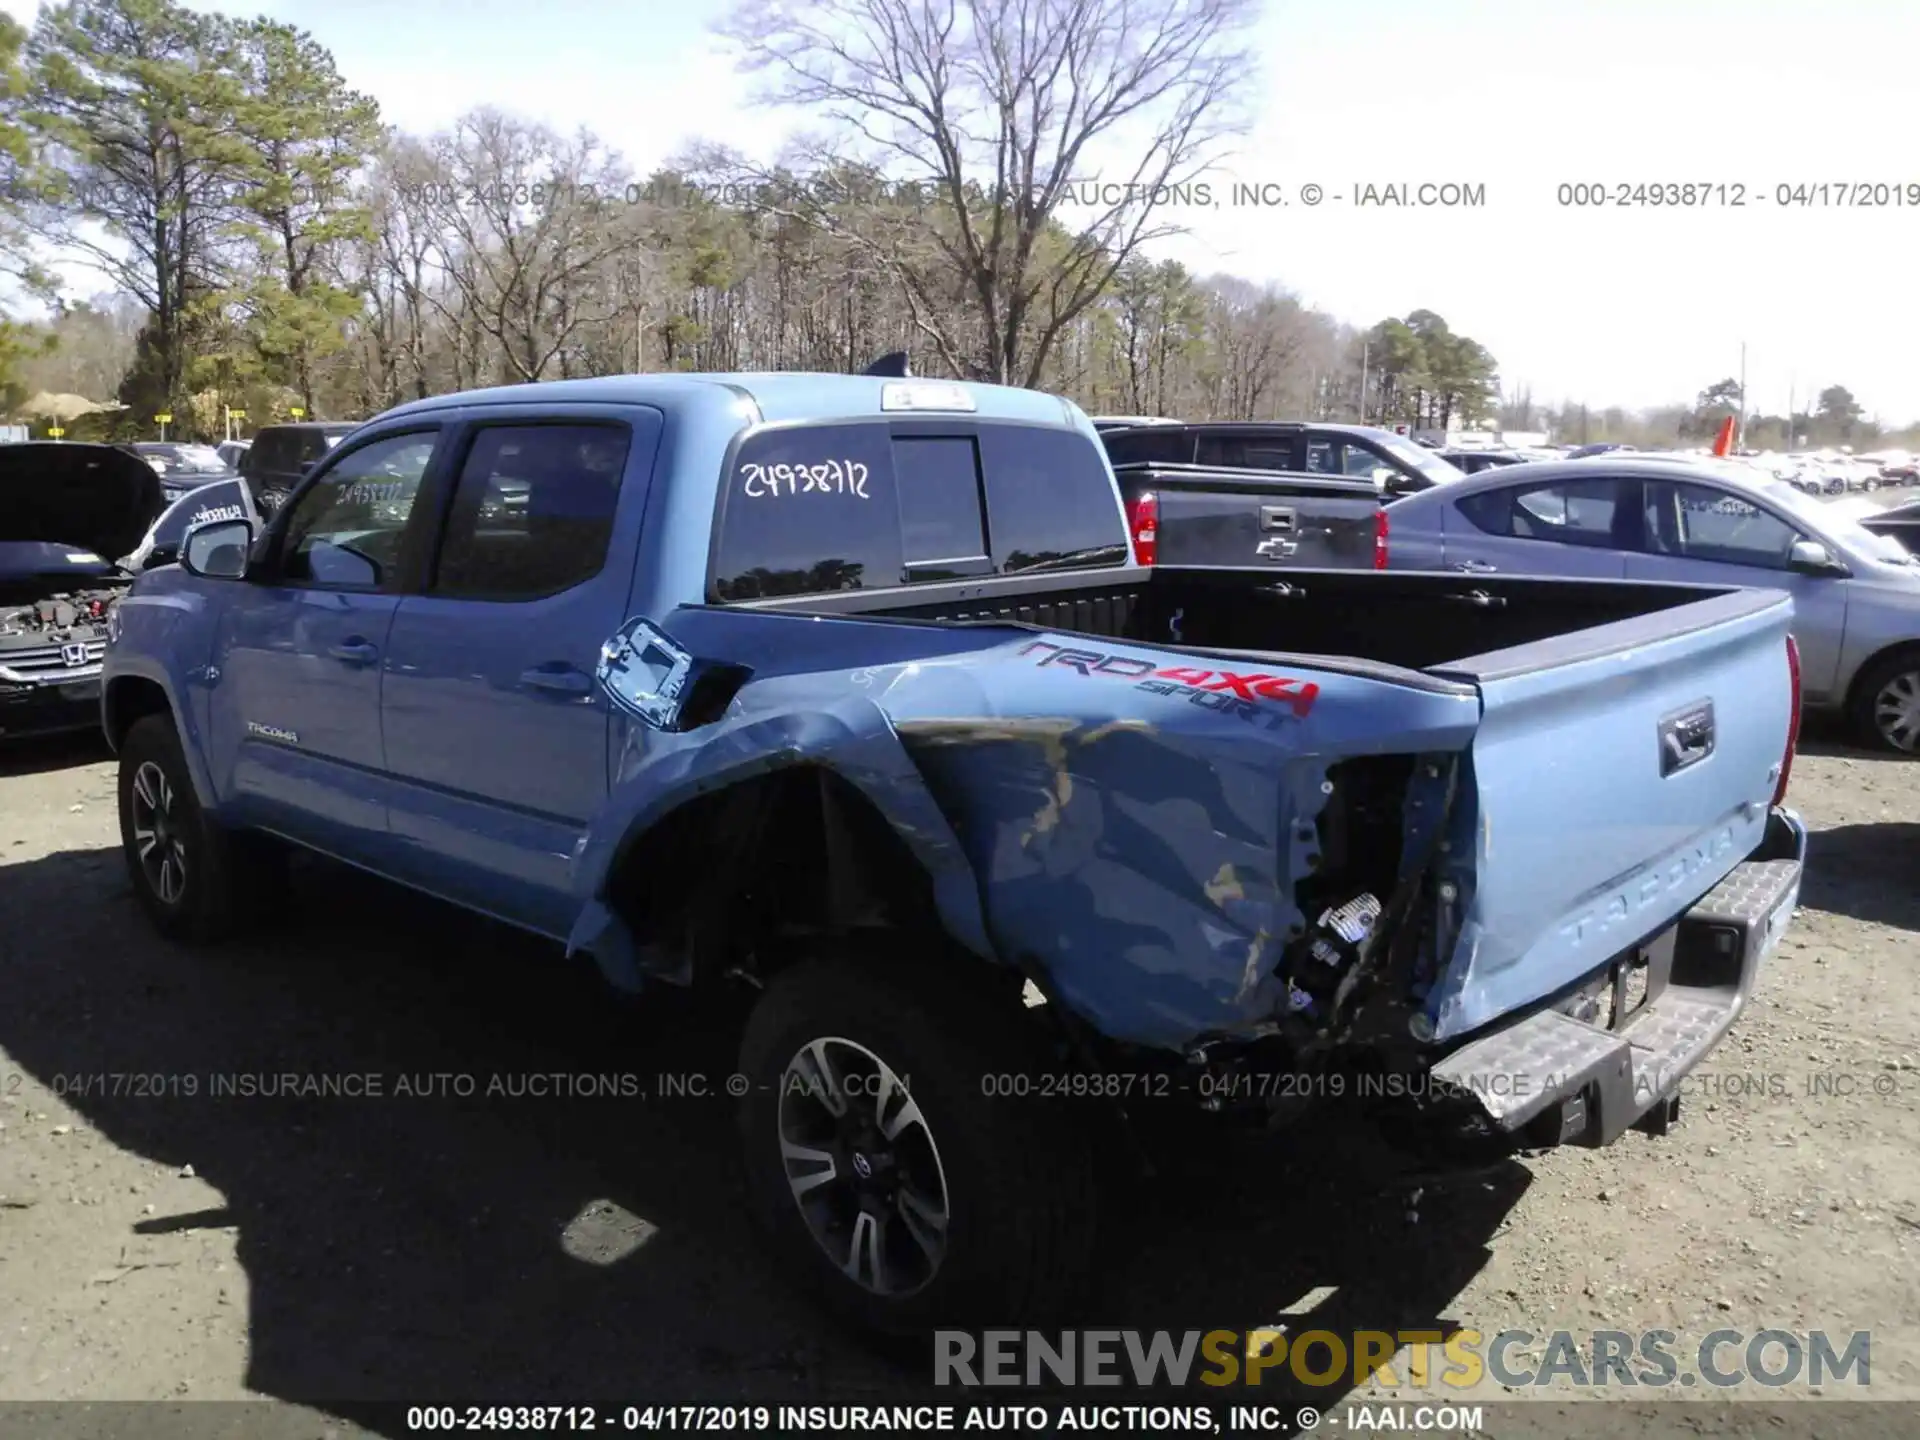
780,1037,950,1298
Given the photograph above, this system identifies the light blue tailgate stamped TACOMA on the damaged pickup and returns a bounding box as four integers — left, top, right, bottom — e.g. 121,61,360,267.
1428,589,1793,1041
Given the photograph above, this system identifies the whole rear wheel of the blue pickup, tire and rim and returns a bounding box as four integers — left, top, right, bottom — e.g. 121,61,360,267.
739,952,1094,1338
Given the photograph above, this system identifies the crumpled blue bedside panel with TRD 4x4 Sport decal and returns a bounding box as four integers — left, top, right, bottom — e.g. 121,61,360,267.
576,609,1478,1048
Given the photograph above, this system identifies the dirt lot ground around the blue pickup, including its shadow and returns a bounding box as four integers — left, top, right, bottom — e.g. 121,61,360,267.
0,672,1920,1434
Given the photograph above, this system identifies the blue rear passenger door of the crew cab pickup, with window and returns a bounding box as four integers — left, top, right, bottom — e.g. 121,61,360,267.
380,405,662,935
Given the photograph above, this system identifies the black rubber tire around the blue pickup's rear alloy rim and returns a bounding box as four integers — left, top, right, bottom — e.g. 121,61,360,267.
739,960,1098,1342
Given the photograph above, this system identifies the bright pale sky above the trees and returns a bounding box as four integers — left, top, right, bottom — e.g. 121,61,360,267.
15,0,1920,422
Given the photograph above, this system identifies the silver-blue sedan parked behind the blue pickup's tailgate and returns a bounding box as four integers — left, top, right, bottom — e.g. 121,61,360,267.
1390,457,1920,755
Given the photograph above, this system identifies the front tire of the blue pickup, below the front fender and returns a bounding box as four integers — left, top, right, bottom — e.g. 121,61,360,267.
119,714,286,945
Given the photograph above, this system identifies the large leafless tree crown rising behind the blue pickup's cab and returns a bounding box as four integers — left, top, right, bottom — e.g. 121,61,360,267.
724,0,1256,384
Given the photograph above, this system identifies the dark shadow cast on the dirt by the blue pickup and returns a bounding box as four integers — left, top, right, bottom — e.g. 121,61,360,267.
0,849,1528,1434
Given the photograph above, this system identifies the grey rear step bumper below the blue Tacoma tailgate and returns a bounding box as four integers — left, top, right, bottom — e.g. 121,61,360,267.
1432,810,1807,1144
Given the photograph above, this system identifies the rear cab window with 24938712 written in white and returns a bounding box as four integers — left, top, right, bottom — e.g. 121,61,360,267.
710,420,1129,601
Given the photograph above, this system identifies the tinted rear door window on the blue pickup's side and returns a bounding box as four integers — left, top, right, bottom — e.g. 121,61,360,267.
432,424,632,601
